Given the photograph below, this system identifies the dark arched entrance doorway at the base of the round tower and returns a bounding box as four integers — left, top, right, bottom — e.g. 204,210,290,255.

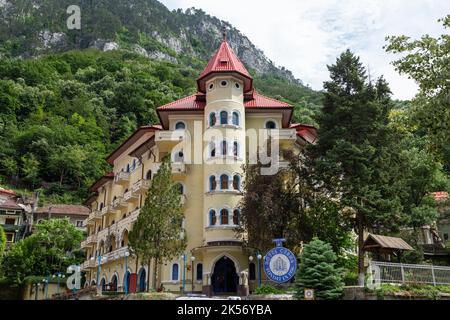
211,256,239,295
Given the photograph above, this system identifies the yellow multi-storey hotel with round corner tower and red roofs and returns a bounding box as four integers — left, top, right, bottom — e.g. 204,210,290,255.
82,39,316,295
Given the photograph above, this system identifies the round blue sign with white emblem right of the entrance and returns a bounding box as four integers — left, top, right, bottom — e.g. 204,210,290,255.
264,247,297,283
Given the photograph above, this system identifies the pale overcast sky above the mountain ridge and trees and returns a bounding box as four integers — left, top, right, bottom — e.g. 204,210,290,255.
160,0,450,99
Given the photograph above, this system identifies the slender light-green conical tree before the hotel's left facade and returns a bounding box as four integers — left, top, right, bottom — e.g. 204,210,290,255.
129,156,186,289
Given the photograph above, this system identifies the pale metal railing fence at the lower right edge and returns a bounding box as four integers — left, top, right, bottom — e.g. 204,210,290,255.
369,261,450,286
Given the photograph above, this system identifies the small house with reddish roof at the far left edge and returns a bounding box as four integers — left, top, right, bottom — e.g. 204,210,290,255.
0,188,26,249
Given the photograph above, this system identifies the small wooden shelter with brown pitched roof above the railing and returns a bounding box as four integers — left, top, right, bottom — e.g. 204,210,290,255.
363,233,414,262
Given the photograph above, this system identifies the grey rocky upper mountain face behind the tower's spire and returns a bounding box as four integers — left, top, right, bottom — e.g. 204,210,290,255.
0,0,301,84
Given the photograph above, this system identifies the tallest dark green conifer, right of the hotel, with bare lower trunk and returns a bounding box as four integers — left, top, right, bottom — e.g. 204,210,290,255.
312,50,406,285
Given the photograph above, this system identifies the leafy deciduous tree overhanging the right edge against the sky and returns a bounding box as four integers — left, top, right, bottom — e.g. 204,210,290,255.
385,15,450,173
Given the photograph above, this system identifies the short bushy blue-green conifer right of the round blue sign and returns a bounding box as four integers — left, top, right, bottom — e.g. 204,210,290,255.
295,239,344,300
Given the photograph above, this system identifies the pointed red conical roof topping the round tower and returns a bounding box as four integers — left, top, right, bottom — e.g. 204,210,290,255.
197,40,253,92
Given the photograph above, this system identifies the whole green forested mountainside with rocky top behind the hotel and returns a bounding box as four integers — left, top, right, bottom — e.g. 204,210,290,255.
0,0,322,203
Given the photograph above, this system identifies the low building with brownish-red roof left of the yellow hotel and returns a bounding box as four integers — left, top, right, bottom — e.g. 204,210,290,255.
36,204,90,232
